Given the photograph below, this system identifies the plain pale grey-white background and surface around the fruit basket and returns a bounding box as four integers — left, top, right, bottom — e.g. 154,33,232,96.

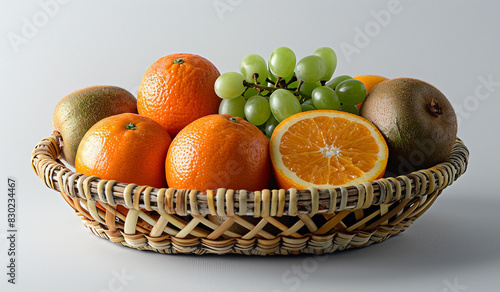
0,0,500,292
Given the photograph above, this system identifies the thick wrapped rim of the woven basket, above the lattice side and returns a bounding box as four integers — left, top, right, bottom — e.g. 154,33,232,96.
31,133,469,217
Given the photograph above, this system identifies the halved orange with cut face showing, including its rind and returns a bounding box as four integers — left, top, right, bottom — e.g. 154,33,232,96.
270,110,389,190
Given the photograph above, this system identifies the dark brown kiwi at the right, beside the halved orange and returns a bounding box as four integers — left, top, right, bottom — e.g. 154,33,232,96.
360,78,457,176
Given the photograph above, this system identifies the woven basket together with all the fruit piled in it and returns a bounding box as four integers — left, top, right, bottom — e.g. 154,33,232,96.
32,47,468,255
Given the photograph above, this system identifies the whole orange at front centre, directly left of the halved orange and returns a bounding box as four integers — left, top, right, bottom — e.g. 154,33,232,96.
165,114,271,192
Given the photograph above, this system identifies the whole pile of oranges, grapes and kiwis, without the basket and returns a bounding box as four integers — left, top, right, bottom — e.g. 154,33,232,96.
49,47,457,192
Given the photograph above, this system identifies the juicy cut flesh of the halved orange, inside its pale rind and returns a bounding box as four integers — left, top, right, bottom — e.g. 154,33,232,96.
279,116,380,185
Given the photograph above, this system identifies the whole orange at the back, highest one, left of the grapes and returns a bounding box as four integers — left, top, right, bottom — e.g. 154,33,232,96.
137,54,221,138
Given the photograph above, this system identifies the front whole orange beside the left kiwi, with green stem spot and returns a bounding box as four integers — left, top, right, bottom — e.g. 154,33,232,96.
75,113,171,188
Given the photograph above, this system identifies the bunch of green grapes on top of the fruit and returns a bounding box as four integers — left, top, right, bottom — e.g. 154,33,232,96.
214,47,366,137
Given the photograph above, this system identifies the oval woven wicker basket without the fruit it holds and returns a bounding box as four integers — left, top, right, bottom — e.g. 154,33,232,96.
31,135,469,255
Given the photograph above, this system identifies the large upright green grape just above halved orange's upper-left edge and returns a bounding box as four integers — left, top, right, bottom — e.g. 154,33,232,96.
269,89,301,122
